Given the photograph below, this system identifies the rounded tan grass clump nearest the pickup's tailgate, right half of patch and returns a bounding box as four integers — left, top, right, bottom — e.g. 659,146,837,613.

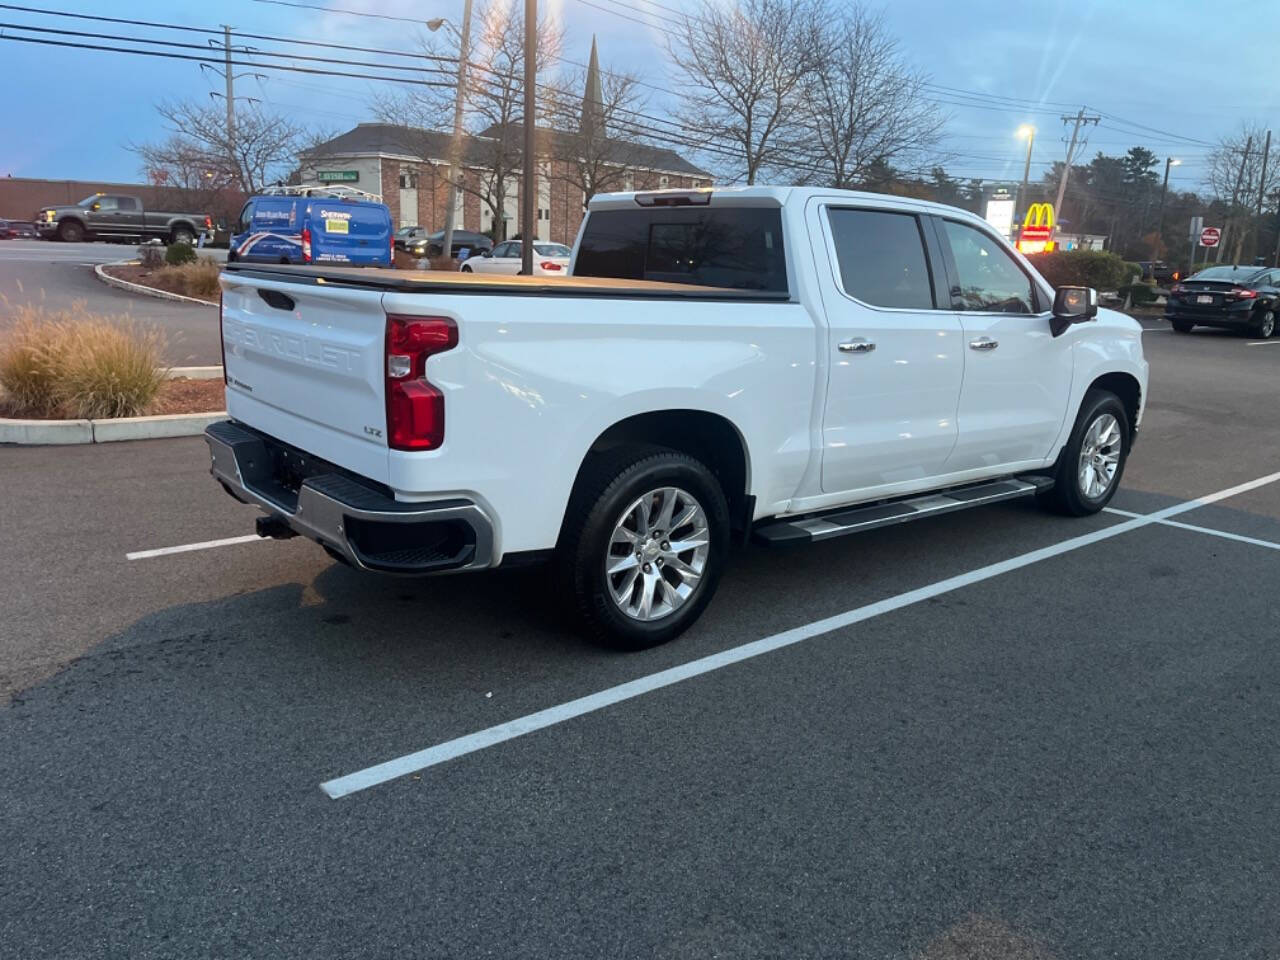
58,317,169,419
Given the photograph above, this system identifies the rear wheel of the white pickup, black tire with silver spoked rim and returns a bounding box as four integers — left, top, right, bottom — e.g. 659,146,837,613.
554,447,730,650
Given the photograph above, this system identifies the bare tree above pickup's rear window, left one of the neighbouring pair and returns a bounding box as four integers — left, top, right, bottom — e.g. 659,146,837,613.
667,0,829,183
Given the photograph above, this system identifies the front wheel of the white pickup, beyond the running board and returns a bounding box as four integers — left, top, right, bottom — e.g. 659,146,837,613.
1039,390,1133,517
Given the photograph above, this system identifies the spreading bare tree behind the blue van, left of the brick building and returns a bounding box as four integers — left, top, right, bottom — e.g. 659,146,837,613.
131,100,305,193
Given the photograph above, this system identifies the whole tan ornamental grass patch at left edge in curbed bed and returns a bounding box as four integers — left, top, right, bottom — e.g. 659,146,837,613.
0,302,169,419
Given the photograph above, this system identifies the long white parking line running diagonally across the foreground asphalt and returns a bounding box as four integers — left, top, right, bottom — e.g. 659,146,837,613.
320,472,1280,800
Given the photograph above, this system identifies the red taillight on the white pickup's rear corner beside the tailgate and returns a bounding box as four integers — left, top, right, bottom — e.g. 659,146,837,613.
387,315,458,451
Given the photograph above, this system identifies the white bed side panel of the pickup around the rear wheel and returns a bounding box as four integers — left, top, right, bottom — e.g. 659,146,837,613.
383,293,815,563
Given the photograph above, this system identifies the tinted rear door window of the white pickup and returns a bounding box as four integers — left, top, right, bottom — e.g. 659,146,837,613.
827,209,934,310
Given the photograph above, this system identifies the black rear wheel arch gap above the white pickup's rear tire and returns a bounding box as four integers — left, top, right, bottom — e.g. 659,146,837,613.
561,408,755,542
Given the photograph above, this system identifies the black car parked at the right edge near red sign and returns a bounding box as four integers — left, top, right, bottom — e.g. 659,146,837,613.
1165,264,1280,339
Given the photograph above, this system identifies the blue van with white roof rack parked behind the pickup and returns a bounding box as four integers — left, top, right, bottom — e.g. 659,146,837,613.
227,191,394,266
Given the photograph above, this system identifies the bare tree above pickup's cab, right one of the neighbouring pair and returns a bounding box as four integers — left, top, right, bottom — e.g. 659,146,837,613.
797,5,946,188
